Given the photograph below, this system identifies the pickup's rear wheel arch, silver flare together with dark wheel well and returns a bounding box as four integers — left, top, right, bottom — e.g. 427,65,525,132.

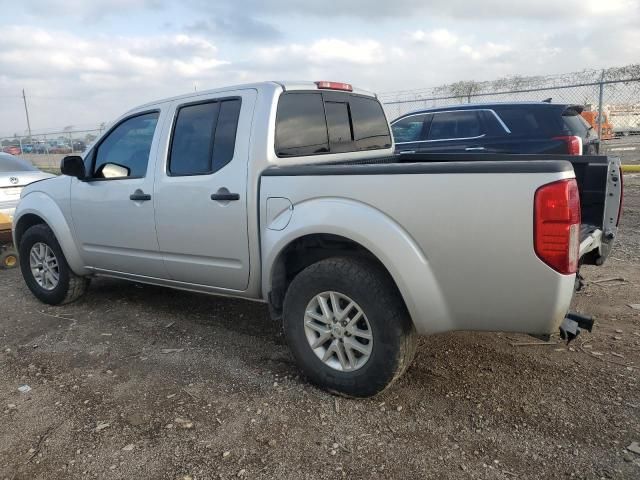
262,198,454,334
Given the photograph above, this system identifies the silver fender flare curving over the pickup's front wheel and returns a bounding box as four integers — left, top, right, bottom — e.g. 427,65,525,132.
13,191,90,275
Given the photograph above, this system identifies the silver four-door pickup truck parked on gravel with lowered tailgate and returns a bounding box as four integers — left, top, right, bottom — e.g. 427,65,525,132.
14,82,622,396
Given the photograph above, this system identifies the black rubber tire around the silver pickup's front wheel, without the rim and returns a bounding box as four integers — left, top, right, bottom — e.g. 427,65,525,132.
19,224,89,305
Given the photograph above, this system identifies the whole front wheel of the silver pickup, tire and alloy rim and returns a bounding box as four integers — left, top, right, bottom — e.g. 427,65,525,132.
20,224,89,305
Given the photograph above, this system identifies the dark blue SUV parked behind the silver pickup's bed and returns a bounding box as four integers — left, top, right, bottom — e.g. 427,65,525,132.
391,102,599,155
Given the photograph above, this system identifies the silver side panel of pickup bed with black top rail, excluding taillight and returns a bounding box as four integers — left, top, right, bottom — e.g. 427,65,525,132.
260,157,575,334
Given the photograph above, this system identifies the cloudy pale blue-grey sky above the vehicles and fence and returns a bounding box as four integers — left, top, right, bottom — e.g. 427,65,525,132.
0,0,640,137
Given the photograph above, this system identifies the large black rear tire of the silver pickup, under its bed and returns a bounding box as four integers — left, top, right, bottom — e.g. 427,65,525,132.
283,257,417,397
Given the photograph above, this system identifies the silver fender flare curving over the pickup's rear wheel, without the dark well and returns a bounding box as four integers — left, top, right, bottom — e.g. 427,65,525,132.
262,198,454,334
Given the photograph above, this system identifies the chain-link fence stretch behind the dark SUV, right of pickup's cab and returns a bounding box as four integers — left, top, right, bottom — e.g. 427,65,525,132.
380,65,640,161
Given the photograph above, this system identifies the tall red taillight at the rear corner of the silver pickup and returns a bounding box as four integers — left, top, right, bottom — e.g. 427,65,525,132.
533,179,580,275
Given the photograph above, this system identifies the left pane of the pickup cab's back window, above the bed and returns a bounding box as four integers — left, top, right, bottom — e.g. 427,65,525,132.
276,93,329,157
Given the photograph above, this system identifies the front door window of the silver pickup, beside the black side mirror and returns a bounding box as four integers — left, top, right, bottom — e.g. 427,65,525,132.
91,112,160,179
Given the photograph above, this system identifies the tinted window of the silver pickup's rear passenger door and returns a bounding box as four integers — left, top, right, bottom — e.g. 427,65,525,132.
169,99,241,176
